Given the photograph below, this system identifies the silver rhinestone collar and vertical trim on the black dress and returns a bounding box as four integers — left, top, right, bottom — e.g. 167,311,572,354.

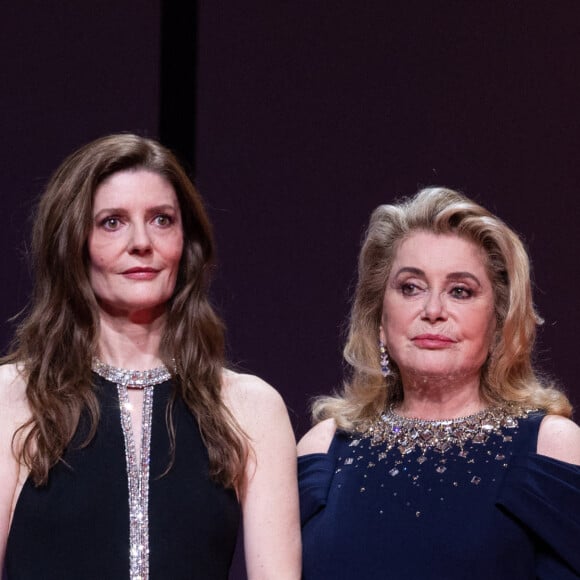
92,359,171,580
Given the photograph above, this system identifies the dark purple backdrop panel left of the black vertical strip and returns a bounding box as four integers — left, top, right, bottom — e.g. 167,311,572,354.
0,0,160,345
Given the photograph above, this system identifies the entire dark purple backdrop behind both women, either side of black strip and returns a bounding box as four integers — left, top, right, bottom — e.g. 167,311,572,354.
0,0,580,578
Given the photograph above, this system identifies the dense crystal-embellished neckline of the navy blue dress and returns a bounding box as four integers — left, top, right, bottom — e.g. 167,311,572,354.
361,403,535,455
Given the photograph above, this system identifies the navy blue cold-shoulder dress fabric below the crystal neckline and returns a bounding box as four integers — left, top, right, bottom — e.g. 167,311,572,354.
299,413,580,580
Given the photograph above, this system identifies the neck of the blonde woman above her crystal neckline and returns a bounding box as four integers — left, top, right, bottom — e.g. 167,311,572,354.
396,376,487,419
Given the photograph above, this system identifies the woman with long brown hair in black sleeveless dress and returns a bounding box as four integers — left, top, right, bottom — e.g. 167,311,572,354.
0,134,300,580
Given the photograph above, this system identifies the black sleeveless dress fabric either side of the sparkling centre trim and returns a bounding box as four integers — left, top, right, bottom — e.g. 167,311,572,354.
5,375,240,580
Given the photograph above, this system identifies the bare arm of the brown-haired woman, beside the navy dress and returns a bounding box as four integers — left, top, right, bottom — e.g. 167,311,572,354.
225,372,301,580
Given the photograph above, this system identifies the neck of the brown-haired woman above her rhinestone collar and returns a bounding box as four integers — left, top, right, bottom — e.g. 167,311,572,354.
98,314,165,370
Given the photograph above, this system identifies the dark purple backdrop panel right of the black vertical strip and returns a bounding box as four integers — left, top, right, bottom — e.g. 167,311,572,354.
197,0,580,440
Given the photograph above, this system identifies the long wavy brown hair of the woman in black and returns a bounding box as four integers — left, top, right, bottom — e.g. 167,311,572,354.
3,134,248,487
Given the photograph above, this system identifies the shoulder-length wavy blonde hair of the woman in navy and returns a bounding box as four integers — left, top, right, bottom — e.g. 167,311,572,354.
313,187,572,430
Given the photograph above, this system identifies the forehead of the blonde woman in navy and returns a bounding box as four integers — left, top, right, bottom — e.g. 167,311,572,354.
391,231,487,277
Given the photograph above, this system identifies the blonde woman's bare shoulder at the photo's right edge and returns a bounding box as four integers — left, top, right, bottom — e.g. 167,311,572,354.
538,415,580,465
